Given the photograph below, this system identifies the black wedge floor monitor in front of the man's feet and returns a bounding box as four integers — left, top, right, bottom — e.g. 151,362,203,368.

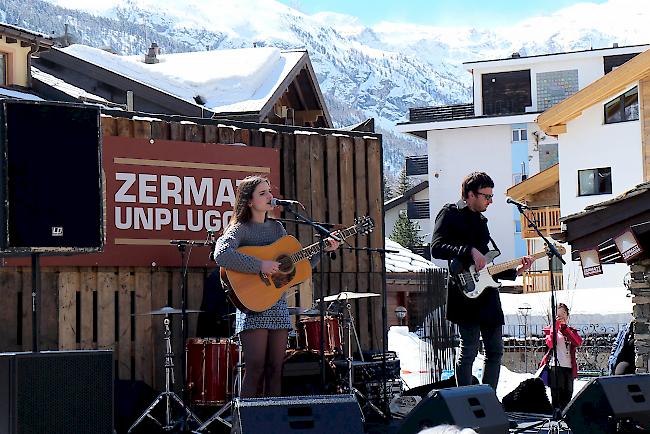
399,385,509,434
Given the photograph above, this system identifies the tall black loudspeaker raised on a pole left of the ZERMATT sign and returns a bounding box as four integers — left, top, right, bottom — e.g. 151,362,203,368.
0,100,104,253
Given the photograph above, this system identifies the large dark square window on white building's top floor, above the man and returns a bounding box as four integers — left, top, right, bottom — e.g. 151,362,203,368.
481,69,532,116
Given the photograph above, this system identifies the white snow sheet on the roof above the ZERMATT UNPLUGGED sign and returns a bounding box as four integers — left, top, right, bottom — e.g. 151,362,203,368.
62,44,306,113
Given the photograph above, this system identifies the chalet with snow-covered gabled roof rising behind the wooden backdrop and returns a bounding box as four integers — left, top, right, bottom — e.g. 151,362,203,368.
34,44,333,128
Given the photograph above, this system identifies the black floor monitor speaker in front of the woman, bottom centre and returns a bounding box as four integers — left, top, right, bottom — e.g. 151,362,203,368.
231,395,363,434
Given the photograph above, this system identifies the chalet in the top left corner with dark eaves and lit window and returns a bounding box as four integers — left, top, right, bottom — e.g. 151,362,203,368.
0,23,54,100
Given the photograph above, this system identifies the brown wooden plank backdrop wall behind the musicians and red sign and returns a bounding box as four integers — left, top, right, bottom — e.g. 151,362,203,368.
0,115,384,390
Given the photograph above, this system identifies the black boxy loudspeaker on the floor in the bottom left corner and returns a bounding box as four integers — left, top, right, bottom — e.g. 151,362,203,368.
0,351,113,434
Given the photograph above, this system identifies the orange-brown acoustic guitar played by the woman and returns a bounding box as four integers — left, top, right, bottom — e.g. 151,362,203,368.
220,216,375,312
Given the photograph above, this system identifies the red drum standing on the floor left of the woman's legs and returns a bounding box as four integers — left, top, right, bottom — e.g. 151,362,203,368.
186,338,239,405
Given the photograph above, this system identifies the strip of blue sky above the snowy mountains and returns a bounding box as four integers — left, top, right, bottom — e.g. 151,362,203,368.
280,0,605,28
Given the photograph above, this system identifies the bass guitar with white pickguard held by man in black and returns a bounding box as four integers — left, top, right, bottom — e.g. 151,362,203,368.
449,245,566,298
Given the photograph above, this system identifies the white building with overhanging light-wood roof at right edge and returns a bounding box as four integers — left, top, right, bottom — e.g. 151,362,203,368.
537,47,650,288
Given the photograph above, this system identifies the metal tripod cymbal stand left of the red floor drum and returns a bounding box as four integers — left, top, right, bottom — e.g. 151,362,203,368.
128,315,201,433
